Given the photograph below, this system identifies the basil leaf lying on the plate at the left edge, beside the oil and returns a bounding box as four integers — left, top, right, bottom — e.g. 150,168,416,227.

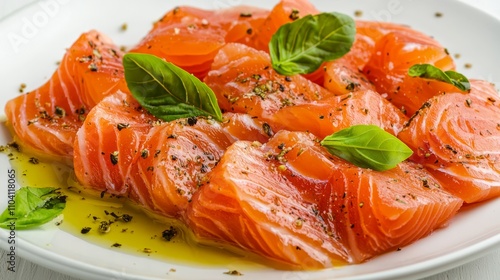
0,187,66,229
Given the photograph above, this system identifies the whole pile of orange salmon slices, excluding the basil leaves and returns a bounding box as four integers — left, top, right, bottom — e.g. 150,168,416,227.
5,0,500,269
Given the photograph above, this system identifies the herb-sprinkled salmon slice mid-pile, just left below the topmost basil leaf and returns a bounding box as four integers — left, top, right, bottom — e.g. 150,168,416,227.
204,43,333,121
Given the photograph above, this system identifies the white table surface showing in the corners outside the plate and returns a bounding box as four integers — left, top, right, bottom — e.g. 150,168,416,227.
0,0,500,280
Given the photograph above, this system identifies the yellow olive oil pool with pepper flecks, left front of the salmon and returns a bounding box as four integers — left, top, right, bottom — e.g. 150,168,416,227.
5,149,274,271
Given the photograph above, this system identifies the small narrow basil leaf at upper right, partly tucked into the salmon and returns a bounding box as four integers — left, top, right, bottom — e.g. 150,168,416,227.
408,64,470,91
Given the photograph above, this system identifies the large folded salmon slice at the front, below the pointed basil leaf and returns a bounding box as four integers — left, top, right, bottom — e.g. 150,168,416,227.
187,130,462,269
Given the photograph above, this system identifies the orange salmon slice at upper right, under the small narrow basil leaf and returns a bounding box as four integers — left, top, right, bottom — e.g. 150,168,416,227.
363,29,455,116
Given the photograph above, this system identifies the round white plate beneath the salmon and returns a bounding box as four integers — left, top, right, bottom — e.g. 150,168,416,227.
0,0,500,279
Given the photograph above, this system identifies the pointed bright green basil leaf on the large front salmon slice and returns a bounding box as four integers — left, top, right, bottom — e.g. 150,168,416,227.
321,125,413,171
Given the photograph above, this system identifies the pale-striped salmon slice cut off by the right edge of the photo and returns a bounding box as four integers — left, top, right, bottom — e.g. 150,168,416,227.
398,82,500,203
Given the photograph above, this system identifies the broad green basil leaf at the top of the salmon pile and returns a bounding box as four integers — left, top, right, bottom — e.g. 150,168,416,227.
269,12,356,75
